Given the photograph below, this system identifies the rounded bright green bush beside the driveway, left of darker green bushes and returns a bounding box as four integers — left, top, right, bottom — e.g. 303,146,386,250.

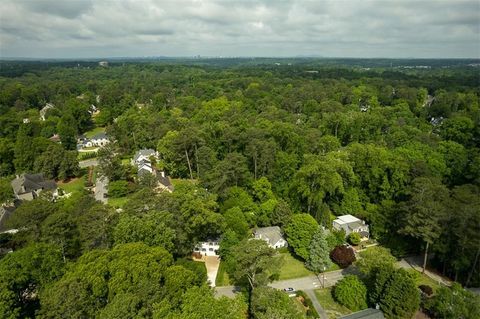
333,275,367,311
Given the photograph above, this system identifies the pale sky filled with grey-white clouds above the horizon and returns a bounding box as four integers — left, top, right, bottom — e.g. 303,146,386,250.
0,0,480,58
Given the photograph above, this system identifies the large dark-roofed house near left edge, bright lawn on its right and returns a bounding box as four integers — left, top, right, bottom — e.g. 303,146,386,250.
11,173,57,200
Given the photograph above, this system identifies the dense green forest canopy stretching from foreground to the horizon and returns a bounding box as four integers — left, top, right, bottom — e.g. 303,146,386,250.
0,60,480,318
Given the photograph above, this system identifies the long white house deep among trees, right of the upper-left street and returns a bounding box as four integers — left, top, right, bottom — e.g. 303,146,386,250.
131,149,173,192
